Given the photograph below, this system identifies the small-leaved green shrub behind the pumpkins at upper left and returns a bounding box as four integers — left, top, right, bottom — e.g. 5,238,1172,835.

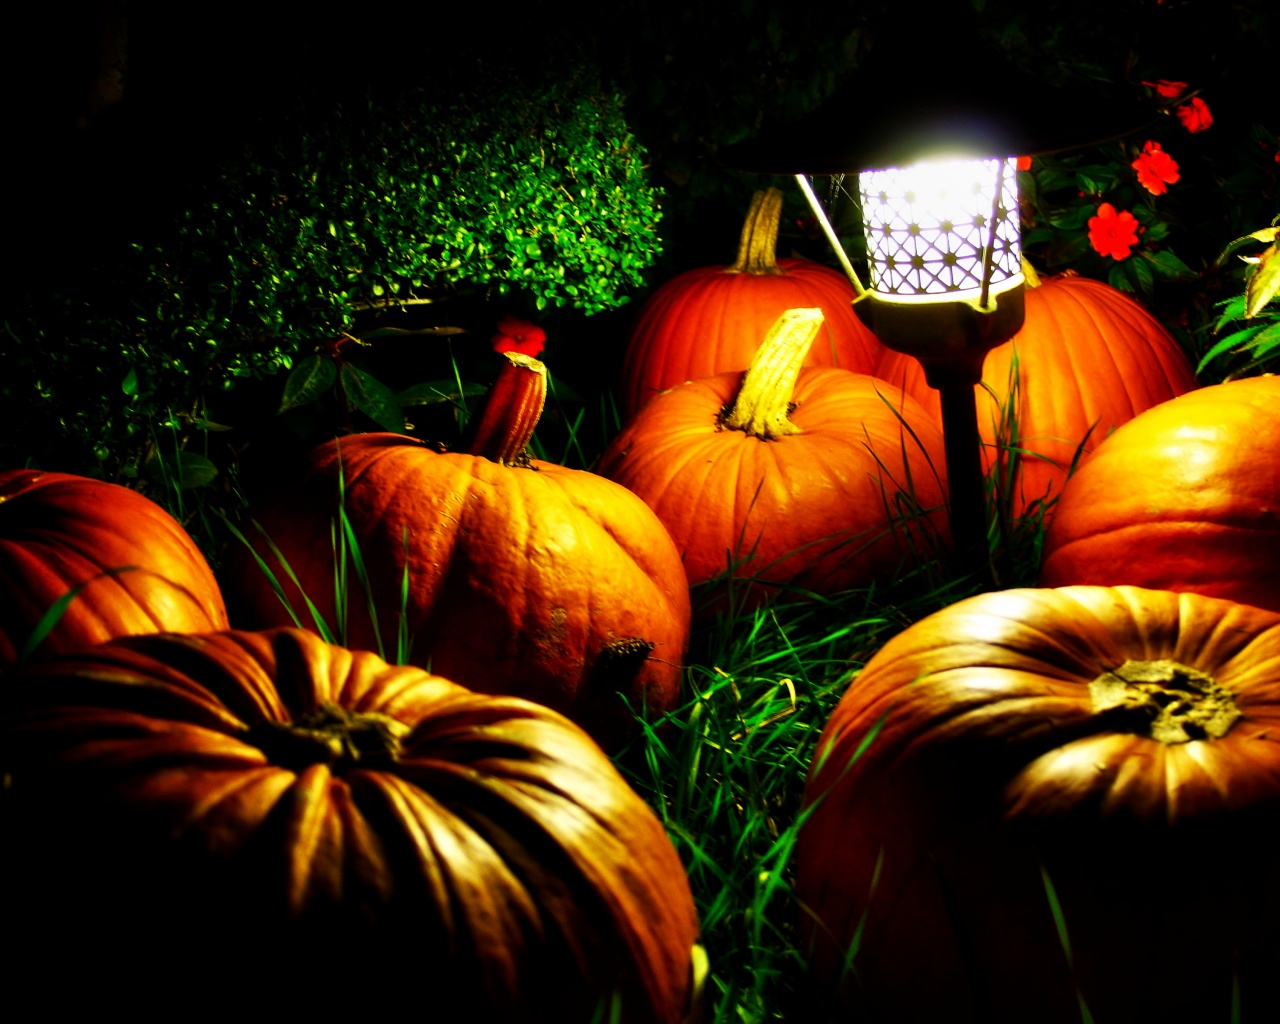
10,60,659,476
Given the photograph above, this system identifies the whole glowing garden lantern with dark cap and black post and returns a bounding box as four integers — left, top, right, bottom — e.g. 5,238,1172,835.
721,14,1152,582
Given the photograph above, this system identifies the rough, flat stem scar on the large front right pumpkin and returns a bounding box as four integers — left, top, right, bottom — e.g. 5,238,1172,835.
1089,658,1240,744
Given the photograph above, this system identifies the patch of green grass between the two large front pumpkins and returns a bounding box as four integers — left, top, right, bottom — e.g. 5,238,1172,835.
616,567,983,1024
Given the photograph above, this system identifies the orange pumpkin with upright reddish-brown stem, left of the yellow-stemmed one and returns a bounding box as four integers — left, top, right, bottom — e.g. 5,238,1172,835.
225,352,690,746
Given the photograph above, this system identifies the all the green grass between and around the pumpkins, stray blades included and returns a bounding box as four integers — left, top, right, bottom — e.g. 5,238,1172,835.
160,353,1059,1024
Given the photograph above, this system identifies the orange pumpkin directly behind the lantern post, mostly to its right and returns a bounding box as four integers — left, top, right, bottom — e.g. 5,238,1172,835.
876,266,1196,520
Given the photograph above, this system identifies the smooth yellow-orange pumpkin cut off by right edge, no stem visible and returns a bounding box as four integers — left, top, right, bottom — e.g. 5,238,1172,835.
1041,375,1280,612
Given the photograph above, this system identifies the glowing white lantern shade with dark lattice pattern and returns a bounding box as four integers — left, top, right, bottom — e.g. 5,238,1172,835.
858,159,1021,301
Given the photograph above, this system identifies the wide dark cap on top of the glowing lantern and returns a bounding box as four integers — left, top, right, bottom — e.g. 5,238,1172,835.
719,19,1157,174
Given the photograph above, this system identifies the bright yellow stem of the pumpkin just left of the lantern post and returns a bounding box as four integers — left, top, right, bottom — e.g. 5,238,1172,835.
721,308,823,440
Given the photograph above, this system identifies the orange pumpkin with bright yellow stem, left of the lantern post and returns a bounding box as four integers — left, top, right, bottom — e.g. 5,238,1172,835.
599,308,946,616
